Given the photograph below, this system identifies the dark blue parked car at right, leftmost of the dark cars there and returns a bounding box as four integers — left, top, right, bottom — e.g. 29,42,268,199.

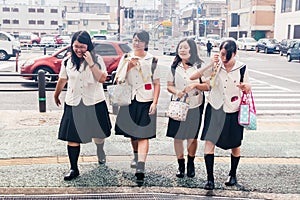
255,38,279,53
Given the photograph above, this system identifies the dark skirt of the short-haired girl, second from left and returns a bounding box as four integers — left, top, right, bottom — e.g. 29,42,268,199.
115,99,157,139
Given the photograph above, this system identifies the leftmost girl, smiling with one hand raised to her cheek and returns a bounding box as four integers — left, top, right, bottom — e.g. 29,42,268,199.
54,31,111,181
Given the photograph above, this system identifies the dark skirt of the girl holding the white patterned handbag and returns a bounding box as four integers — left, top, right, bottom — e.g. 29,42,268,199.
167,106,203,140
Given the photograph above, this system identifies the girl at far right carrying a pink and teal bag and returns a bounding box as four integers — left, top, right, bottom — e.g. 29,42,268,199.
191,40,251,190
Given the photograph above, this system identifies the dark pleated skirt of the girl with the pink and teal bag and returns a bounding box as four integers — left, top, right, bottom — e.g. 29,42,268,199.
201,104,244,150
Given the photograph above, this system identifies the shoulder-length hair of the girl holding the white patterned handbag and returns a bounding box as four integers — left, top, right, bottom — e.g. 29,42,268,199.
171,38,203,69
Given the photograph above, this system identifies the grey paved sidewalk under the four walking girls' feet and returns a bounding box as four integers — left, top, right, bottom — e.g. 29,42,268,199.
0,110,300,199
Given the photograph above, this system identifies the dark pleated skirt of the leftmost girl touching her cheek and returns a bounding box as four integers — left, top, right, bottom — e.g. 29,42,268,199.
58,101,112,143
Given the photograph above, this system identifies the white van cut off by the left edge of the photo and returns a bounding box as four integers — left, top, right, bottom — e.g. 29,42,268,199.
0,31,21,60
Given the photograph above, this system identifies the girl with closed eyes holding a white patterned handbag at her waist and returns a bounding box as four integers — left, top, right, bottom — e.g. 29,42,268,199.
167,39,209,178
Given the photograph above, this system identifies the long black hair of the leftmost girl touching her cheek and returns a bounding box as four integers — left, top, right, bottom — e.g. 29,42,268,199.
71,31,97,71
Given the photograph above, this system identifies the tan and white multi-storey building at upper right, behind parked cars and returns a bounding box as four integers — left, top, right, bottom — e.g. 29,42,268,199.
227,0,276,40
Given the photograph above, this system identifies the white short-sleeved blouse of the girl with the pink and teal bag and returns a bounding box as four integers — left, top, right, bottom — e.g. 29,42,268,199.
204,61,249,113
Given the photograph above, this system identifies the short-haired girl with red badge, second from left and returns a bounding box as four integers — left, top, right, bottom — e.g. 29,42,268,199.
115,30,161,184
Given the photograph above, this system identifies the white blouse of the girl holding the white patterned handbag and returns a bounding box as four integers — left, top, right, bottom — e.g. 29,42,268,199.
167,63,204,109
